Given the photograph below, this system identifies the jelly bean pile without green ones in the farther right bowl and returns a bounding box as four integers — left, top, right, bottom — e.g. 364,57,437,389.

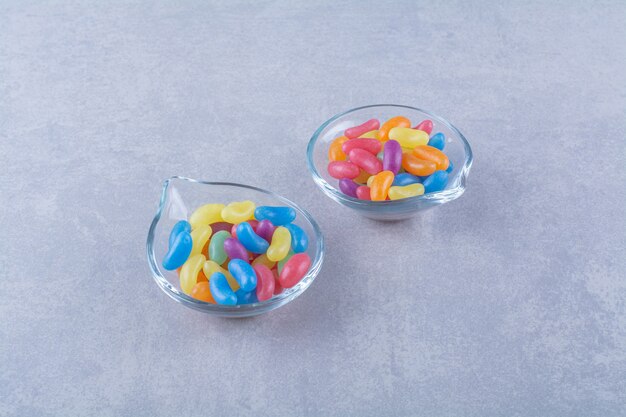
328,116,453,201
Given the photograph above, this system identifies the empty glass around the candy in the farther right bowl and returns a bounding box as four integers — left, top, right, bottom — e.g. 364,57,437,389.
307,104,472,220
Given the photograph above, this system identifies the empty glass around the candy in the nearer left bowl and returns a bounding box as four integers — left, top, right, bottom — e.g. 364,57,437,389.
147,177,324,317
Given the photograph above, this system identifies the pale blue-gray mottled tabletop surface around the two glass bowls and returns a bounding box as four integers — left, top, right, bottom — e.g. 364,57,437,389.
0,1,626,416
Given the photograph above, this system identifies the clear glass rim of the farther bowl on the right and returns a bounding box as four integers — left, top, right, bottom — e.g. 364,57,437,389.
306,104,474,209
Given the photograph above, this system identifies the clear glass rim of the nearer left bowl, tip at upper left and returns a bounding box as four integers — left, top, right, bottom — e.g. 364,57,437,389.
146,176,324,317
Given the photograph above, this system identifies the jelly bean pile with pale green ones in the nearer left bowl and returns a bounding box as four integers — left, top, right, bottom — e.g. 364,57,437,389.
163,201,311,305
